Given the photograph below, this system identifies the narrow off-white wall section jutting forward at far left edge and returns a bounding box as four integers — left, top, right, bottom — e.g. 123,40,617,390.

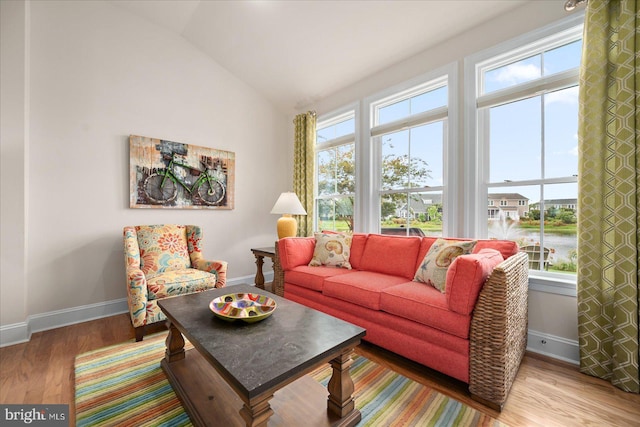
0,1,29,335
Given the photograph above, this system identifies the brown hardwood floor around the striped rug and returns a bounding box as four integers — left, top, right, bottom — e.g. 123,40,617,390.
0,314,640,427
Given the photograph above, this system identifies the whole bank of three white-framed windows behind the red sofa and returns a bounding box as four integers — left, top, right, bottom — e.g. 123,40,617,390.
314,13,584,295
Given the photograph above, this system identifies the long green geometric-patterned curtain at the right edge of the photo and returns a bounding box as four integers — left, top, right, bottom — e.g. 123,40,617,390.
578,0,640,393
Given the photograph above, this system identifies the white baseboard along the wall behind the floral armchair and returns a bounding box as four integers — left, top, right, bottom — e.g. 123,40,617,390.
0,271,273,347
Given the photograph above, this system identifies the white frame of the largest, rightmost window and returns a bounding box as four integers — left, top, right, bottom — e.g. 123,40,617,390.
463,11,584,296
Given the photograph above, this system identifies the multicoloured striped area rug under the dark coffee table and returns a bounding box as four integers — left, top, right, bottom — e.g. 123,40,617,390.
75,333,504,427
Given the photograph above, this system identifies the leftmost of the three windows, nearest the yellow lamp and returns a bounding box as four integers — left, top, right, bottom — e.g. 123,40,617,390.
314,110,356,231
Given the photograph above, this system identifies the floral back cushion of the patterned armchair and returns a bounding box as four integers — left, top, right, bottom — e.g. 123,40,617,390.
136,224,191,275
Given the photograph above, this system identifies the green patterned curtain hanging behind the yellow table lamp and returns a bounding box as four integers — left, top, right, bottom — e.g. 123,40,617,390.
293,111,316,236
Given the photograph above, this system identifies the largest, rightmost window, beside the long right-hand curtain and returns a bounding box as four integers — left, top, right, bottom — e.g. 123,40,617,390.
466,17,582,280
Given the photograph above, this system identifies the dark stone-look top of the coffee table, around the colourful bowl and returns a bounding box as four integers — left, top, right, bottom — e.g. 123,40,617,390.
158,285,366,398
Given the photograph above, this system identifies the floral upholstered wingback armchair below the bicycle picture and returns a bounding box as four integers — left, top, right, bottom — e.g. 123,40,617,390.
123,224,227,341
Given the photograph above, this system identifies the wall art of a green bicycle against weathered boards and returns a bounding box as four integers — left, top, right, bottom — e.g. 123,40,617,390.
129,135,235,209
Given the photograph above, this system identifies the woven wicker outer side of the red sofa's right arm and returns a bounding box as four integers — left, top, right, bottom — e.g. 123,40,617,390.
469,252,529,410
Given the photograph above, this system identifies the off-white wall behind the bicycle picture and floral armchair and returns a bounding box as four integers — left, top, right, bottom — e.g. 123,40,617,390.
0,1,292,341
